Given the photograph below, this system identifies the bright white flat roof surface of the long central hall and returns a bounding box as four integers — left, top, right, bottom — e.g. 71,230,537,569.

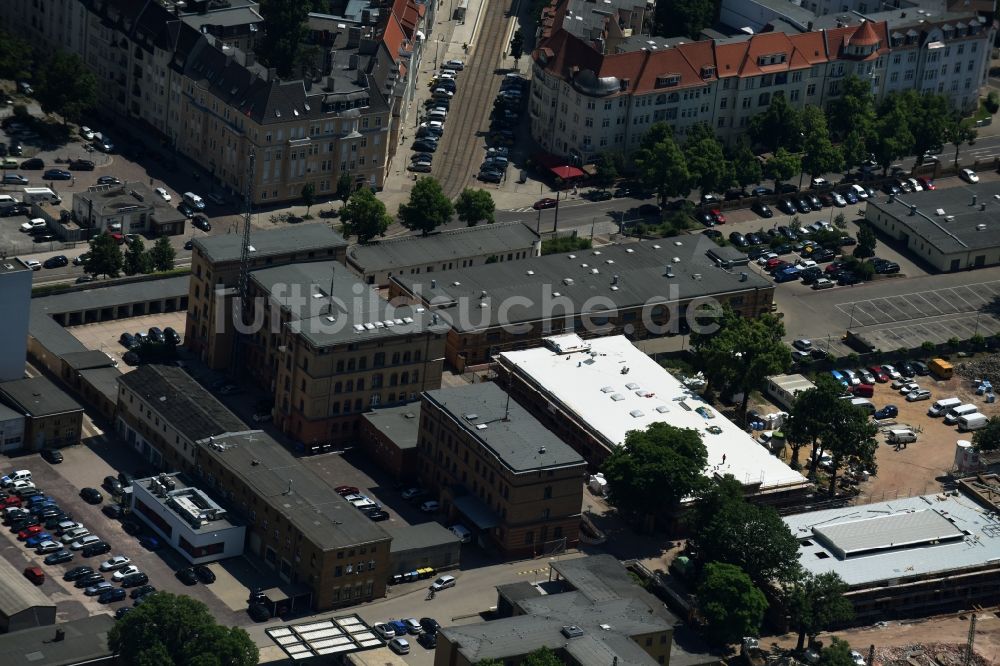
500,336,806,489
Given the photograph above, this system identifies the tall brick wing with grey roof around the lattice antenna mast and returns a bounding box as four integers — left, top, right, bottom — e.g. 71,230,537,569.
184,224,347,370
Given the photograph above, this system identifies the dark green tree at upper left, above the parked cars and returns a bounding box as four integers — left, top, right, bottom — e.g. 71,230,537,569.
34,50,97,123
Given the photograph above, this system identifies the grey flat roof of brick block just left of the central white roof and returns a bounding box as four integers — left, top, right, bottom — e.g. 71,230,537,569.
424,382,586,474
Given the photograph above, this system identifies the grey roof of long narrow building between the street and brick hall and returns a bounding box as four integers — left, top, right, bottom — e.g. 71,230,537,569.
347,222,538,272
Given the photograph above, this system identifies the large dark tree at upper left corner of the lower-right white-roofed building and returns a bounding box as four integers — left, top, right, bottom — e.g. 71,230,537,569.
692,475,799,588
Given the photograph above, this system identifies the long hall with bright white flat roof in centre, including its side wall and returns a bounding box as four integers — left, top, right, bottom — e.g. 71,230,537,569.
497,334,811,505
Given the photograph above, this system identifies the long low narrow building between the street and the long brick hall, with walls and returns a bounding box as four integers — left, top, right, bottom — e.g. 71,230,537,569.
347,222,542,287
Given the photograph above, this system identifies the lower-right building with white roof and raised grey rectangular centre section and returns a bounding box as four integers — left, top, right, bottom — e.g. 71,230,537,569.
783,477,1000,624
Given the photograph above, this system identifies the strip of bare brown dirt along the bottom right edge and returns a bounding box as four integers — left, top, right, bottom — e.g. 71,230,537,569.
761,609,1000,666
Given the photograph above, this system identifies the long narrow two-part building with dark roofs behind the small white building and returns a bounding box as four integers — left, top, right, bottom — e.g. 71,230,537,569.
116,365,391,611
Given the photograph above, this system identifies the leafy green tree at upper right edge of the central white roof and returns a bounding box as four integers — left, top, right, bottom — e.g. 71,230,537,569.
691,307,792,416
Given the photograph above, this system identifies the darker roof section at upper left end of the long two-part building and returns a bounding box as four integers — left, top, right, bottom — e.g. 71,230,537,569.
118,364,248,442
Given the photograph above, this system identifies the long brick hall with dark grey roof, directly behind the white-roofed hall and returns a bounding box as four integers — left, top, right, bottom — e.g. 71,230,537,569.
389,235,774,371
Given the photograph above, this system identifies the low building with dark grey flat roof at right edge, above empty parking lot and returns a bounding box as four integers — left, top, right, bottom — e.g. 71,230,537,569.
865,183,1000,273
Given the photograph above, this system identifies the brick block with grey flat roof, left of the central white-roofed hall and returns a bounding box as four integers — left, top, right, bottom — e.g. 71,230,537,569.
417,382,587,557
